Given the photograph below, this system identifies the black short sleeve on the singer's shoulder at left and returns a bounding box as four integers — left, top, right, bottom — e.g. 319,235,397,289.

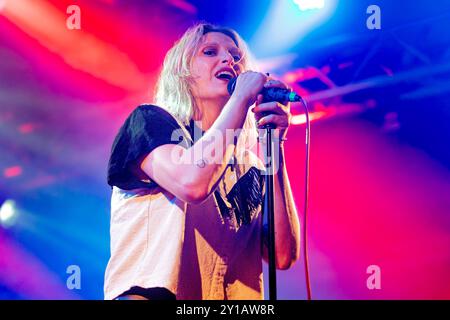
107,104,189,190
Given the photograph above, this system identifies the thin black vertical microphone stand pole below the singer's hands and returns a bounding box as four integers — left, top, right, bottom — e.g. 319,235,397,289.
263,124,277,301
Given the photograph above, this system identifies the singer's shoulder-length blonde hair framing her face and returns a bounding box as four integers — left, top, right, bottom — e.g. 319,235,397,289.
155,22,257,153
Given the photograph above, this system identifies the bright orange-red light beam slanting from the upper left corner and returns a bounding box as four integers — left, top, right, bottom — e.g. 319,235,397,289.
0,0,148,92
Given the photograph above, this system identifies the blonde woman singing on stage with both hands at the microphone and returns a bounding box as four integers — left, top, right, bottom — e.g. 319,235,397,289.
105,23,300,299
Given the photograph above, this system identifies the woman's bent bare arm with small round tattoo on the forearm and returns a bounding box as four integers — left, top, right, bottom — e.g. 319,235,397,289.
140,72,266,203
